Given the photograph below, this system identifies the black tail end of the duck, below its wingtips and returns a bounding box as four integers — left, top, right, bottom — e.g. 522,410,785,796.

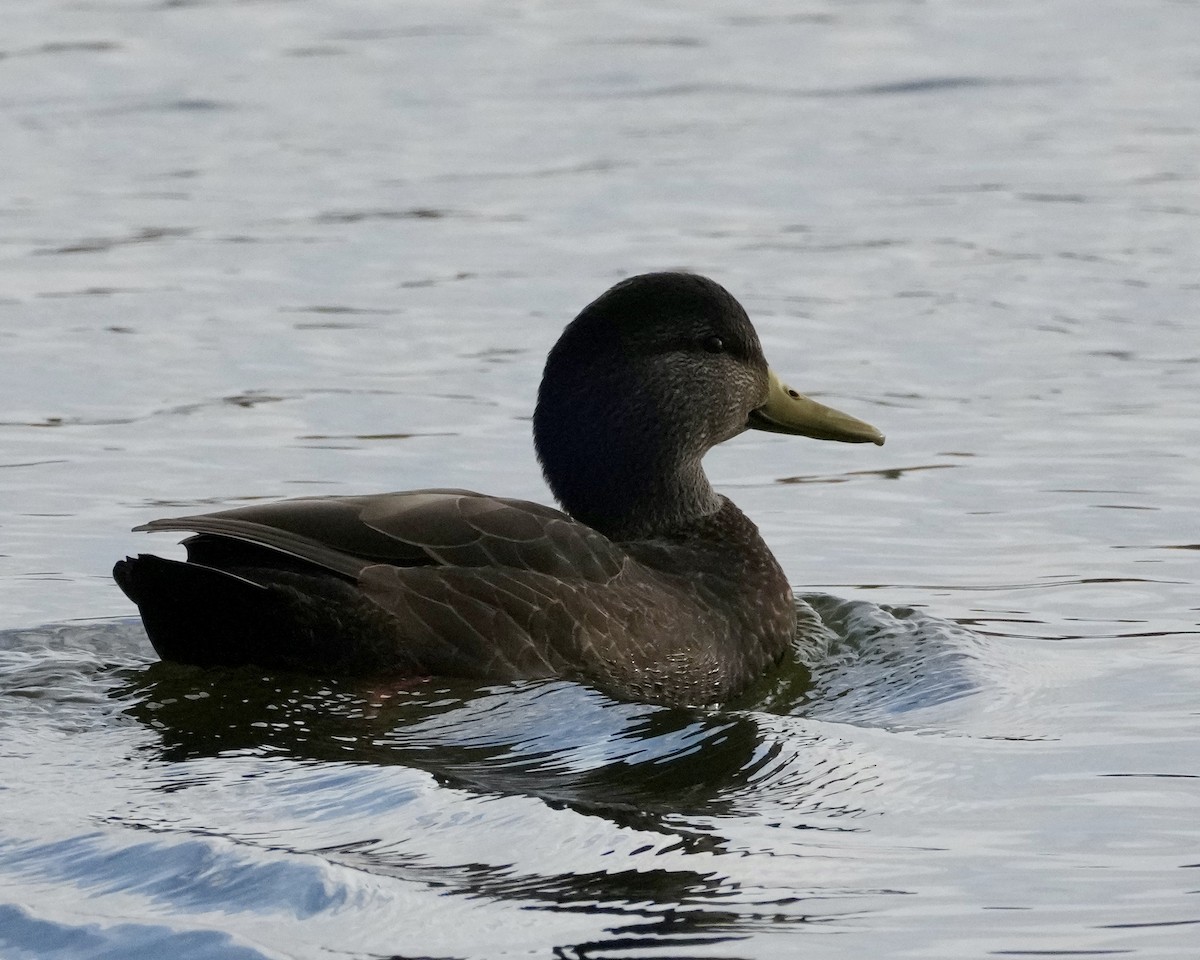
113,553,300,666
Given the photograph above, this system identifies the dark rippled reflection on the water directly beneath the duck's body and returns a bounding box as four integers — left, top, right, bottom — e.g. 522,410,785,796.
112,664,801,829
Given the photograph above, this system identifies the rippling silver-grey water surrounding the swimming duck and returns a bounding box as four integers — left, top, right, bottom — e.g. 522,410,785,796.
0,0,1200,960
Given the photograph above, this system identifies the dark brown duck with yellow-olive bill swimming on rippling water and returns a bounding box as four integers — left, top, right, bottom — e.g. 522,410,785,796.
113,272,884,706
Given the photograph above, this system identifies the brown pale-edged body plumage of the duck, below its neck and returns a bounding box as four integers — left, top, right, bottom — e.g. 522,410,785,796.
119,491,794,703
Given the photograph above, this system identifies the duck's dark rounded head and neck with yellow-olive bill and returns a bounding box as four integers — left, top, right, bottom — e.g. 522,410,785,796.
533,272,883,539
